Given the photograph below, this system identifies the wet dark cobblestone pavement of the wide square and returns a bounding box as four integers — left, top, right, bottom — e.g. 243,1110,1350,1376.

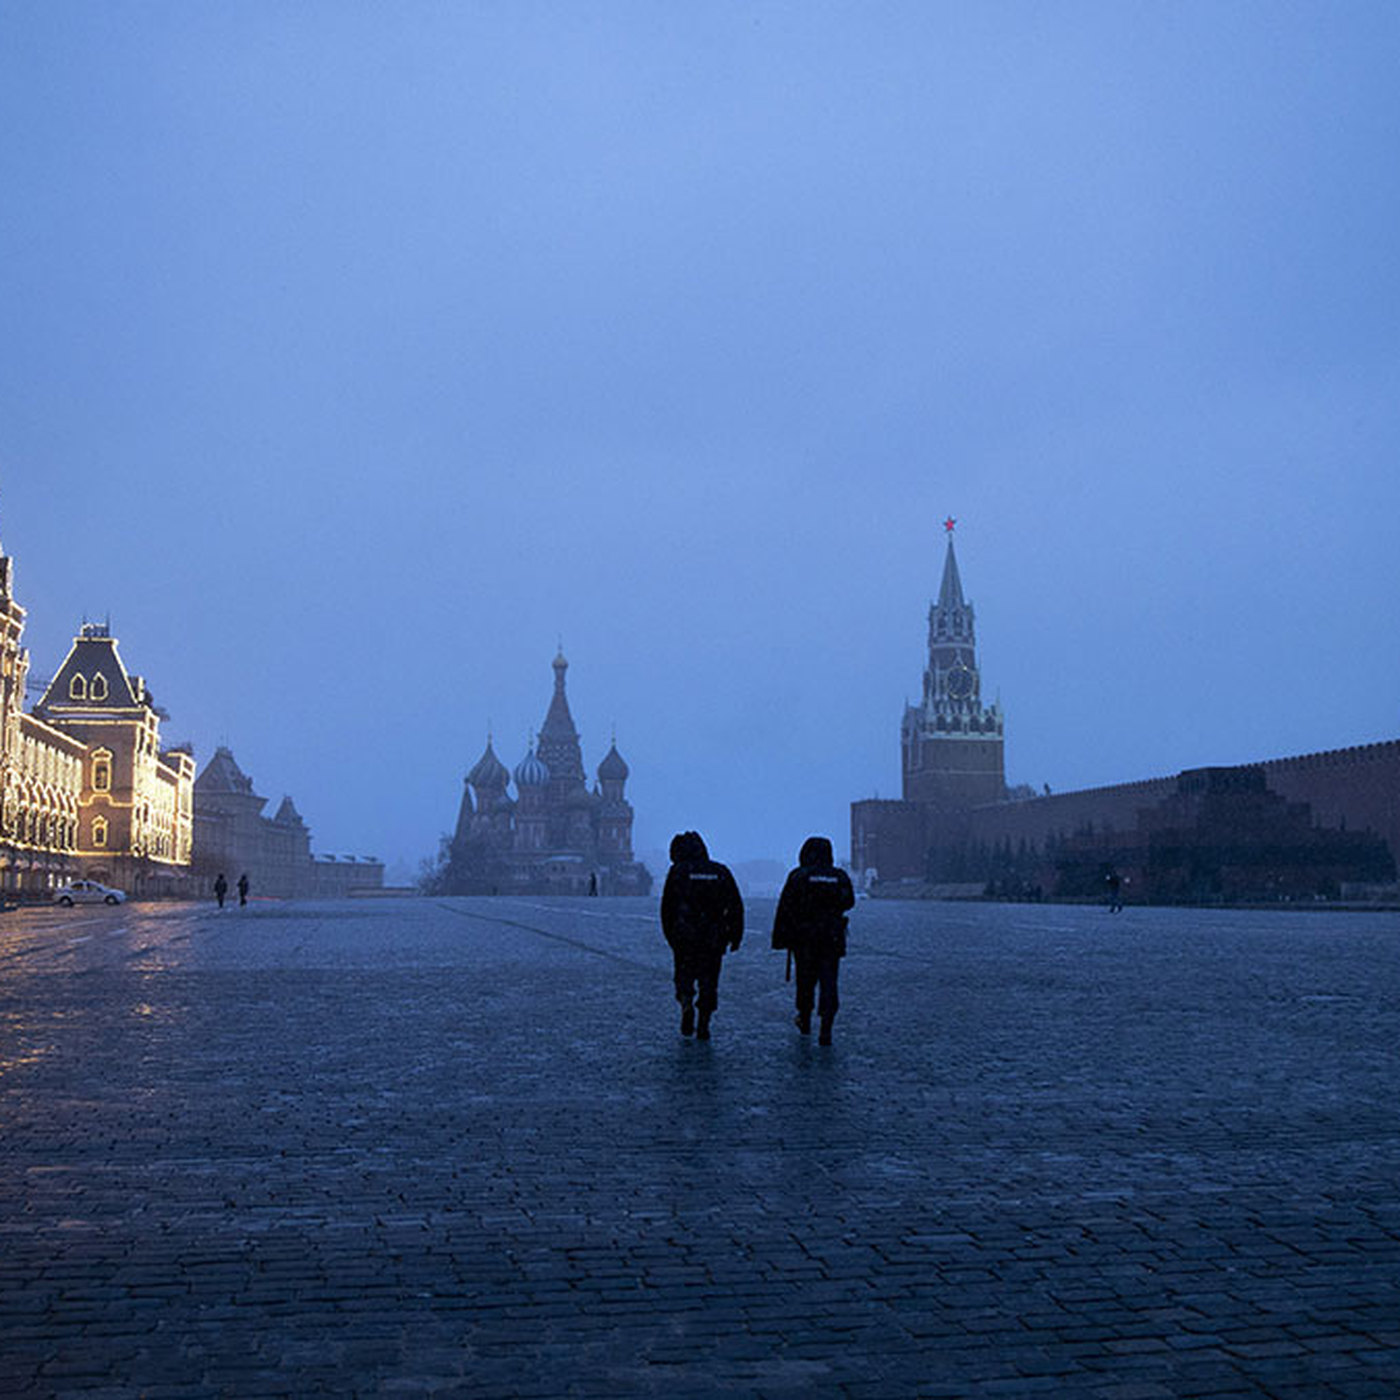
0,899,1400,1400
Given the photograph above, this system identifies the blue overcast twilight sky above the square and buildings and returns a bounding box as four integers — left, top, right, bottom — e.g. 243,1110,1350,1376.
0,0,1400,865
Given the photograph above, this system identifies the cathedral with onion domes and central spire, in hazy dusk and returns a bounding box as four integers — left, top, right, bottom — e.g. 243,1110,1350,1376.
433,652,651,895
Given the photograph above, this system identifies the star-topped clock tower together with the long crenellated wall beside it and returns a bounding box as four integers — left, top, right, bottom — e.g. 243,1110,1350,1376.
851,519,1400,903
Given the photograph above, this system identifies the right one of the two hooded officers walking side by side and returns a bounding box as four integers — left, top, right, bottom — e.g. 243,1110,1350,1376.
773,836,855,1046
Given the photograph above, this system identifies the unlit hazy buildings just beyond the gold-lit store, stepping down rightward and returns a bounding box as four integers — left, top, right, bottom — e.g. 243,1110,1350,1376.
195,746,384,899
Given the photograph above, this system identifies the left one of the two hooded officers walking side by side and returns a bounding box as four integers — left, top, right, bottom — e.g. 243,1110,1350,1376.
661,832,743,1040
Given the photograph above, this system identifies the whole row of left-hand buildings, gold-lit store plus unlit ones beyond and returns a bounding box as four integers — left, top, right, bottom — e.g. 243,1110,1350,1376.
0,529,384,897
